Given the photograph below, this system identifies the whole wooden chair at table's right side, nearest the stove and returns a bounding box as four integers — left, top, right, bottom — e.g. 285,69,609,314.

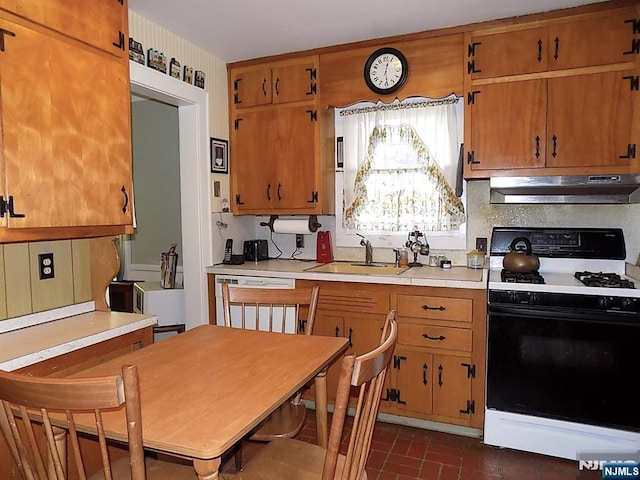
222,310,398,480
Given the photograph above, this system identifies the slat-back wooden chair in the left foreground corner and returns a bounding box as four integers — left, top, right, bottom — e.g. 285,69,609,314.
0,365,197,480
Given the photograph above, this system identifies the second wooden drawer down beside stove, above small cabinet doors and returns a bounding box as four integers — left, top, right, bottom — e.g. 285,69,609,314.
398,322,472,352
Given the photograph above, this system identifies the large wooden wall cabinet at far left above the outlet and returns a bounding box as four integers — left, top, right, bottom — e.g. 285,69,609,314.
0,0,132,241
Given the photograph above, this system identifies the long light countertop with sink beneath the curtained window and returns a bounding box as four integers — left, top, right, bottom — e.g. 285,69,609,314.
206,259,488,289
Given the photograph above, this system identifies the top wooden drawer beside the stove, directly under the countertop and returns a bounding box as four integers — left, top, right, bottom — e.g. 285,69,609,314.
397,295,473,322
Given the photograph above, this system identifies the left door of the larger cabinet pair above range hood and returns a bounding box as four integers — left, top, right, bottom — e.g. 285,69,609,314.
467,80,547,170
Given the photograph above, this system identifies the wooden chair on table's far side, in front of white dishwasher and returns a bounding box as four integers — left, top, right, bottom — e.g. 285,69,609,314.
222,283,319,470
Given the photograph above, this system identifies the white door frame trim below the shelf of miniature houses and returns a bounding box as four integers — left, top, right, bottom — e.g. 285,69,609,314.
129,62,212,329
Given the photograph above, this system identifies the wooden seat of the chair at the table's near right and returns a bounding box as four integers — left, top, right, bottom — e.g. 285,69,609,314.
222,439,367,480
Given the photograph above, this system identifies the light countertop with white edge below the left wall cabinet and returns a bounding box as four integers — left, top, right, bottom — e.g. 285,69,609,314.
0,311,157,371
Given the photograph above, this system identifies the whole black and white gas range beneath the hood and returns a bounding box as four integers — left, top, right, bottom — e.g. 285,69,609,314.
484,227,640,459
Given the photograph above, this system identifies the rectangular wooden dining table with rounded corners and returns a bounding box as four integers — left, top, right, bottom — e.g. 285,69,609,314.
67,325,347,480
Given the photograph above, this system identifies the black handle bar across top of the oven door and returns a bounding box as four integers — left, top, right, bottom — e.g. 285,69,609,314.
488,304,640,326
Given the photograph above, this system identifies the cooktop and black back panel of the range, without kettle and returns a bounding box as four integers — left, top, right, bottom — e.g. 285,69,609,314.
488,227,640,313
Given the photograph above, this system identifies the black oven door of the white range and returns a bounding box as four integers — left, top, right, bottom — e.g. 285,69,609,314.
487,304,640,431
